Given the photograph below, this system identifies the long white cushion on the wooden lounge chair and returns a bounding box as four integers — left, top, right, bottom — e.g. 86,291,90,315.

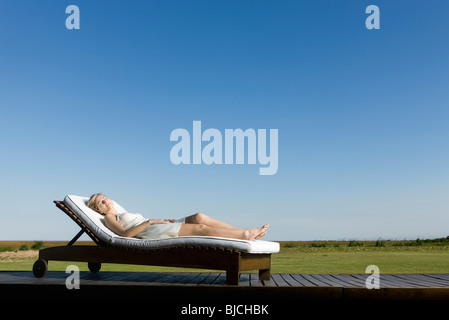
64,195,279,253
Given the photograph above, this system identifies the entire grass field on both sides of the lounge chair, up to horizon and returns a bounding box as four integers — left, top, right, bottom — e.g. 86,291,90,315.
0,238,449,273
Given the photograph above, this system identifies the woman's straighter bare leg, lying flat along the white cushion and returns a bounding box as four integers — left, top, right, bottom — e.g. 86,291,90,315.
178,223,268,240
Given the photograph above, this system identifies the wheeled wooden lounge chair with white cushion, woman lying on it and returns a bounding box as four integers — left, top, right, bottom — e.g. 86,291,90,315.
33,195,279,285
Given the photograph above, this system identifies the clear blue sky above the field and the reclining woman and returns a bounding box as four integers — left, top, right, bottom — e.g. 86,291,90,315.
0,0,449,240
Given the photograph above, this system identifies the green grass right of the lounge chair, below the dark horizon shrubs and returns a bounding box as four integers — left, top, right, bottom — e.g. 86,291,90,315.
272,246,449,273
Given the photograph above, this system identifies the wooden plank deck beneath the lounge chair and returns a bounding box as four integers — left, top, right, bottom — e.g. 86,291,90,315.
0,271,449,302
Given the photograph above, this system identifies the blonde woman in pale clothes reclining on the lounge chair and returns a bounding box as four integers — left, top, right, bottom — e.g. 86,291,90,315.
87,193,268,240
